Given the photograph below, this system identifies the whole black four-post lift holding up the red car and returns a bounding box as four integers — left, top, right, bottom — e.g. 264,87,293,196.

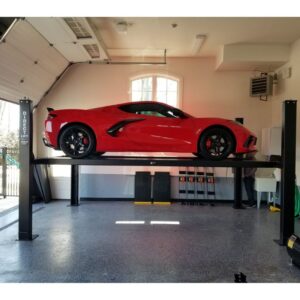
19,100,297,245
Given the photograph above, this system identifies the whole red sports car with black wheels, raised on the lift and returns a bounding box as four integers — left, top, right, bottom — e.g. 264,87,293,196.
43,101,256,160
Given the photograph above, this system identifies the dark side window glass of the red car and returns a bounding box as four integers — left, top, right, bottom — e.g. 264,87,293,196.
119,103,190,119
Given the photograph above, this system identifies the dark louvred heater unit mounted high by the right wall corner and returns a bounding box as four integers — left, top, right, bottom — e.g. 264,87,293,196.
250,75,273,100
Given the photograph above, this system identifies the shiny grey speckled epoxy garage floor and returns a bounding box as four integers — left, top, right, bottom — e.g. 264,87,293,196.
0,201,300,282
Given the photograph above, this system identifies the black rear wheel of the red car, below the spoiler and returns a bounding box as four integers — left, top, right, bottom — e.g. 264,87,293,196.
59,124,96,158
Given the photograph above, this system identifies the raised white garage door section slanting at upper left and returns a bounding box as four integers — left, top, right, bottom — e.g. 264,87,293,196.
0,20,69,104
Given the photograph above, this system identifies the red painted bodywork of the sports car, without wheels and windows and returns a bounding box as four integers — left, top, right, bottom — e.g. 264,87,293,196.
44,101,256,153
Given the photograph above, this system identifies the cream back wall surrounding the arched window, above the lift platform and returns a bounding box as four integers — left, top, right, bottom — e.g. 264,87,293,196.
37,58,272,157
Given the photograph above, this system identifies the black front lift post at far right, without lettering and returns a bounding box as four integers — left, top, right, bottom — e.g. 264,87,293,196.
279,100,297,245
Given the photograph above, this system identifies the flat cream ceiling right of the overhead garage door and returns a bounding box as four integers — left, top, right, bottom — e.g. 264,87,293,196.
89,17,300,57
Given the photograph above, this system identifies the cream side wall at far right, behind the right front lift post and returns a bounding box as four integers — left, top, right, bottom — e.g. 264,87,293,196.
271,39,300,185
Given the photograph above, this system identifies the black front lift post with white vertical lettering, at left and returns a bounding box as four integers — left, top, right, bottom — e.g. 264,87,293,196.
19,100,37,241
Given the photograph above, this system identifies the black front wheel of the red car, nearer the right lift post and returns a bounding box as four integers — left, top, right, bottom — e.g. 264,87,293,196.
199,127,234,160
